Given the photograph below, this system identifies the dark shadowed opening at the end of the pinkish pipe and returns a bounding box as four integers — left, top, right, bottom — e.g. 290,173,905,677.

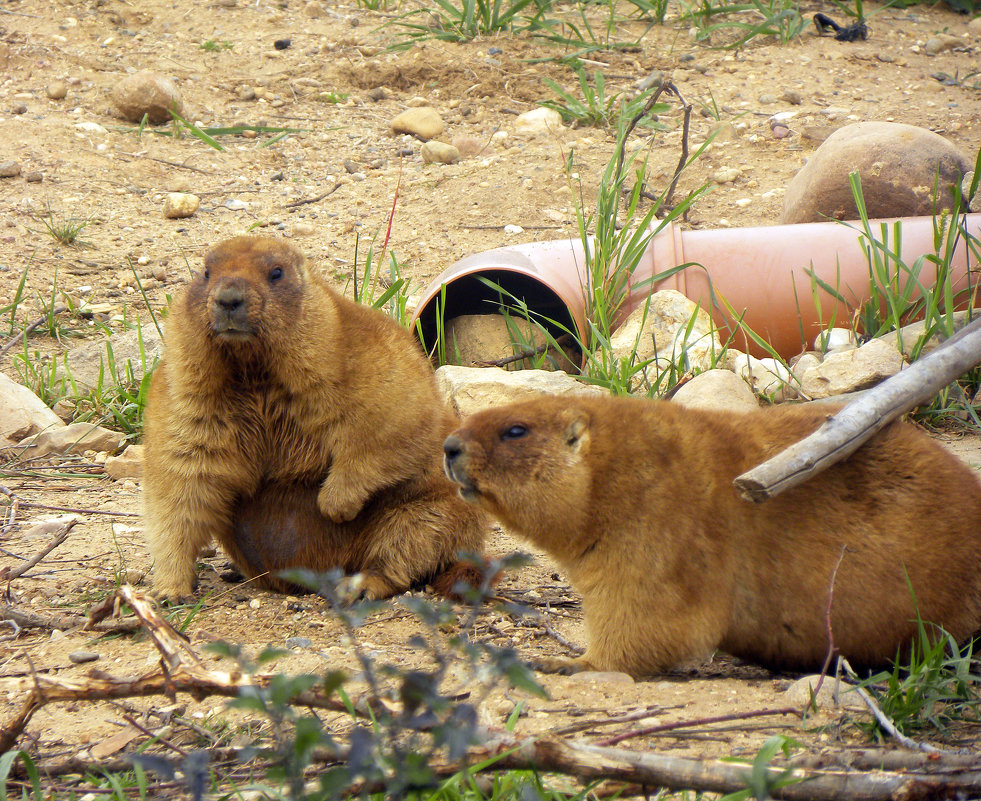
415,270,579,366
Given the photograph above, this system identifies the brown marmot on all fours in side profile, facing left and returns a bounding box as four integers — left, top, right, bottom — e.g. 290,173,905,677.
443,397,981,676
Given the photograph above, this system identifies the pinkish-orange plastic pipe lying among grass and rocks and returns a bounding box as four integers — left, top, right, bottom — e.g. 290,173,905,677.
413,214,981,358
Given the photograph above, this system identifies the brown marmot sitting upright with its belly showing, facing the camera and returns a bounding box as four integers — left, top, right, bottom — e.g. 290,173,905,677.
143,237,488,600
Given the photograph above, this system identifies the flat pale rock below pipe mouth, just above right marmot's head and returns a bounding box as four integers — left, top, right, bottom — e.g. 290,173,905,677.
436,365,603,417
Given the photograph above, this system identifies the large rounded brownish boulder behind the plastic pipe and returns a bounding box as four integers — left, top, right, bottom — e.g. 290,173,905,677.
780,122,973,223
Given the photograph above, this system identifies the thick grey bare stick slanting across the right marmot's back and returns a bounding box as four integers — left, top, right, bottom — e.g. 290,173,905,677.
733,312,981,503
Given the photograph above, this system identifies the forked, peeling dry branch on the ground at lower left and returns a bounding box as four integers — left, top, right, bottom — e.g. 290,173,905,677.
0,586,366,753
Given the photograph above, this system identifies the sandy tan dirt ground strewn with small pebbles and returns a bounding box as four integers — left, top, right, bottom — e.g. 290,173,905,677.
0,0,981,792
